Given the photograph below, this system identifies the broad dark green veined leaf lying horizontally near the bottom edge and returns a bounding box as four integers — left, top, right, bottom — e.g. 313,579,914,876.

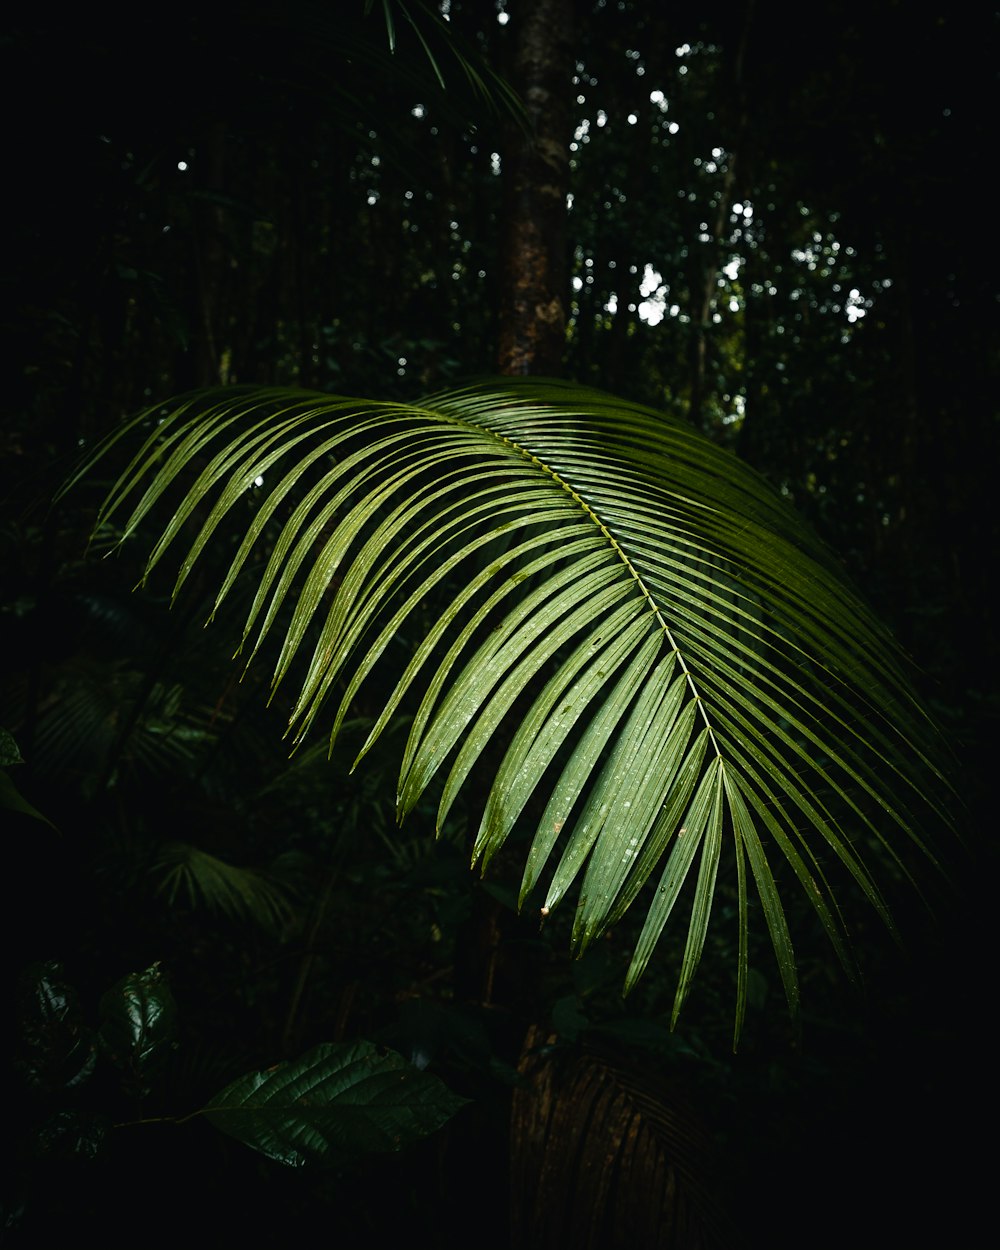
205,1041,468,1168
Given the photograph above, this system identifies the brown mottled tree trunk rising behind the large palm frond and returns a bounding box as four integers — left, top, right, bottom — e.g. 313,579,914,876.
498,0,574,375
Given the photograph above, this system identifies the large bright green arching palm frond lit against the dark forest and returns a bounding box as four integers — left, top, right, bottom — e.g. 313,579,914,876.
66,379,943,1031
